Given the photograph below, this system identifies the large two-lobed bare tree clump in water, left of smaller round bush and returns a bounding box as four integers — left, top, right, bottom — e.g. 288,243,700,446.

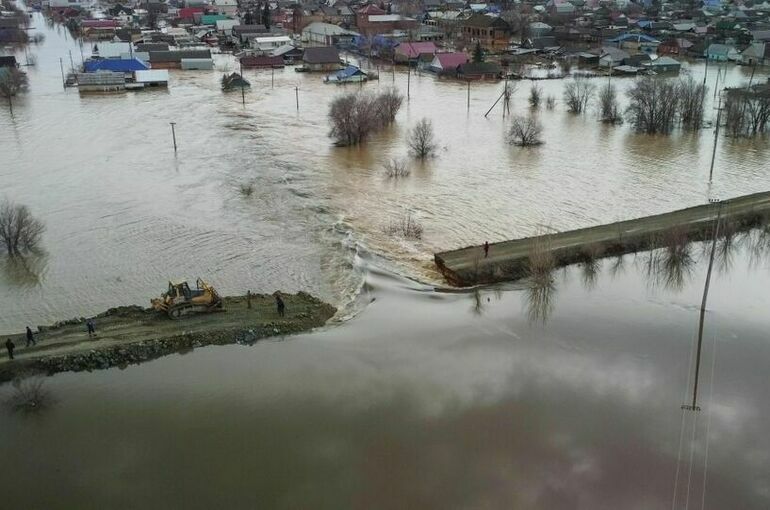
329,90,403,146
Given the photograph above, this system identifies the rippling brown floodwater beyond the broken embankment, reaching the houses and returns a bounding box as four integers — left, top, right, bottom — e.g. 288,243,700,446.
0,14,770,331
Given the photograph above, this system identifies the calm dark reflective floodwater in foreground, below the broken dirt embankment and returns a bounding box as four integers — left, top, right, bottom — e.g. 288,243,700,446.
0,236,770,510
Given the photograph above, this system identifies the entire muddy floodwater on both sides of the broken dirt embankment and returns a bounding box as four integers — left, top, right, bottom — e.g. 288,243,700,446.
0,11,770,509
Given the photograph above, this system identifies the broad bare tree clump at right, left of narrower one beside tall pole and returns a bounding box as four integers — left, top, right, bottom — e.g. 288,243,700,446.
626,77,679,134
